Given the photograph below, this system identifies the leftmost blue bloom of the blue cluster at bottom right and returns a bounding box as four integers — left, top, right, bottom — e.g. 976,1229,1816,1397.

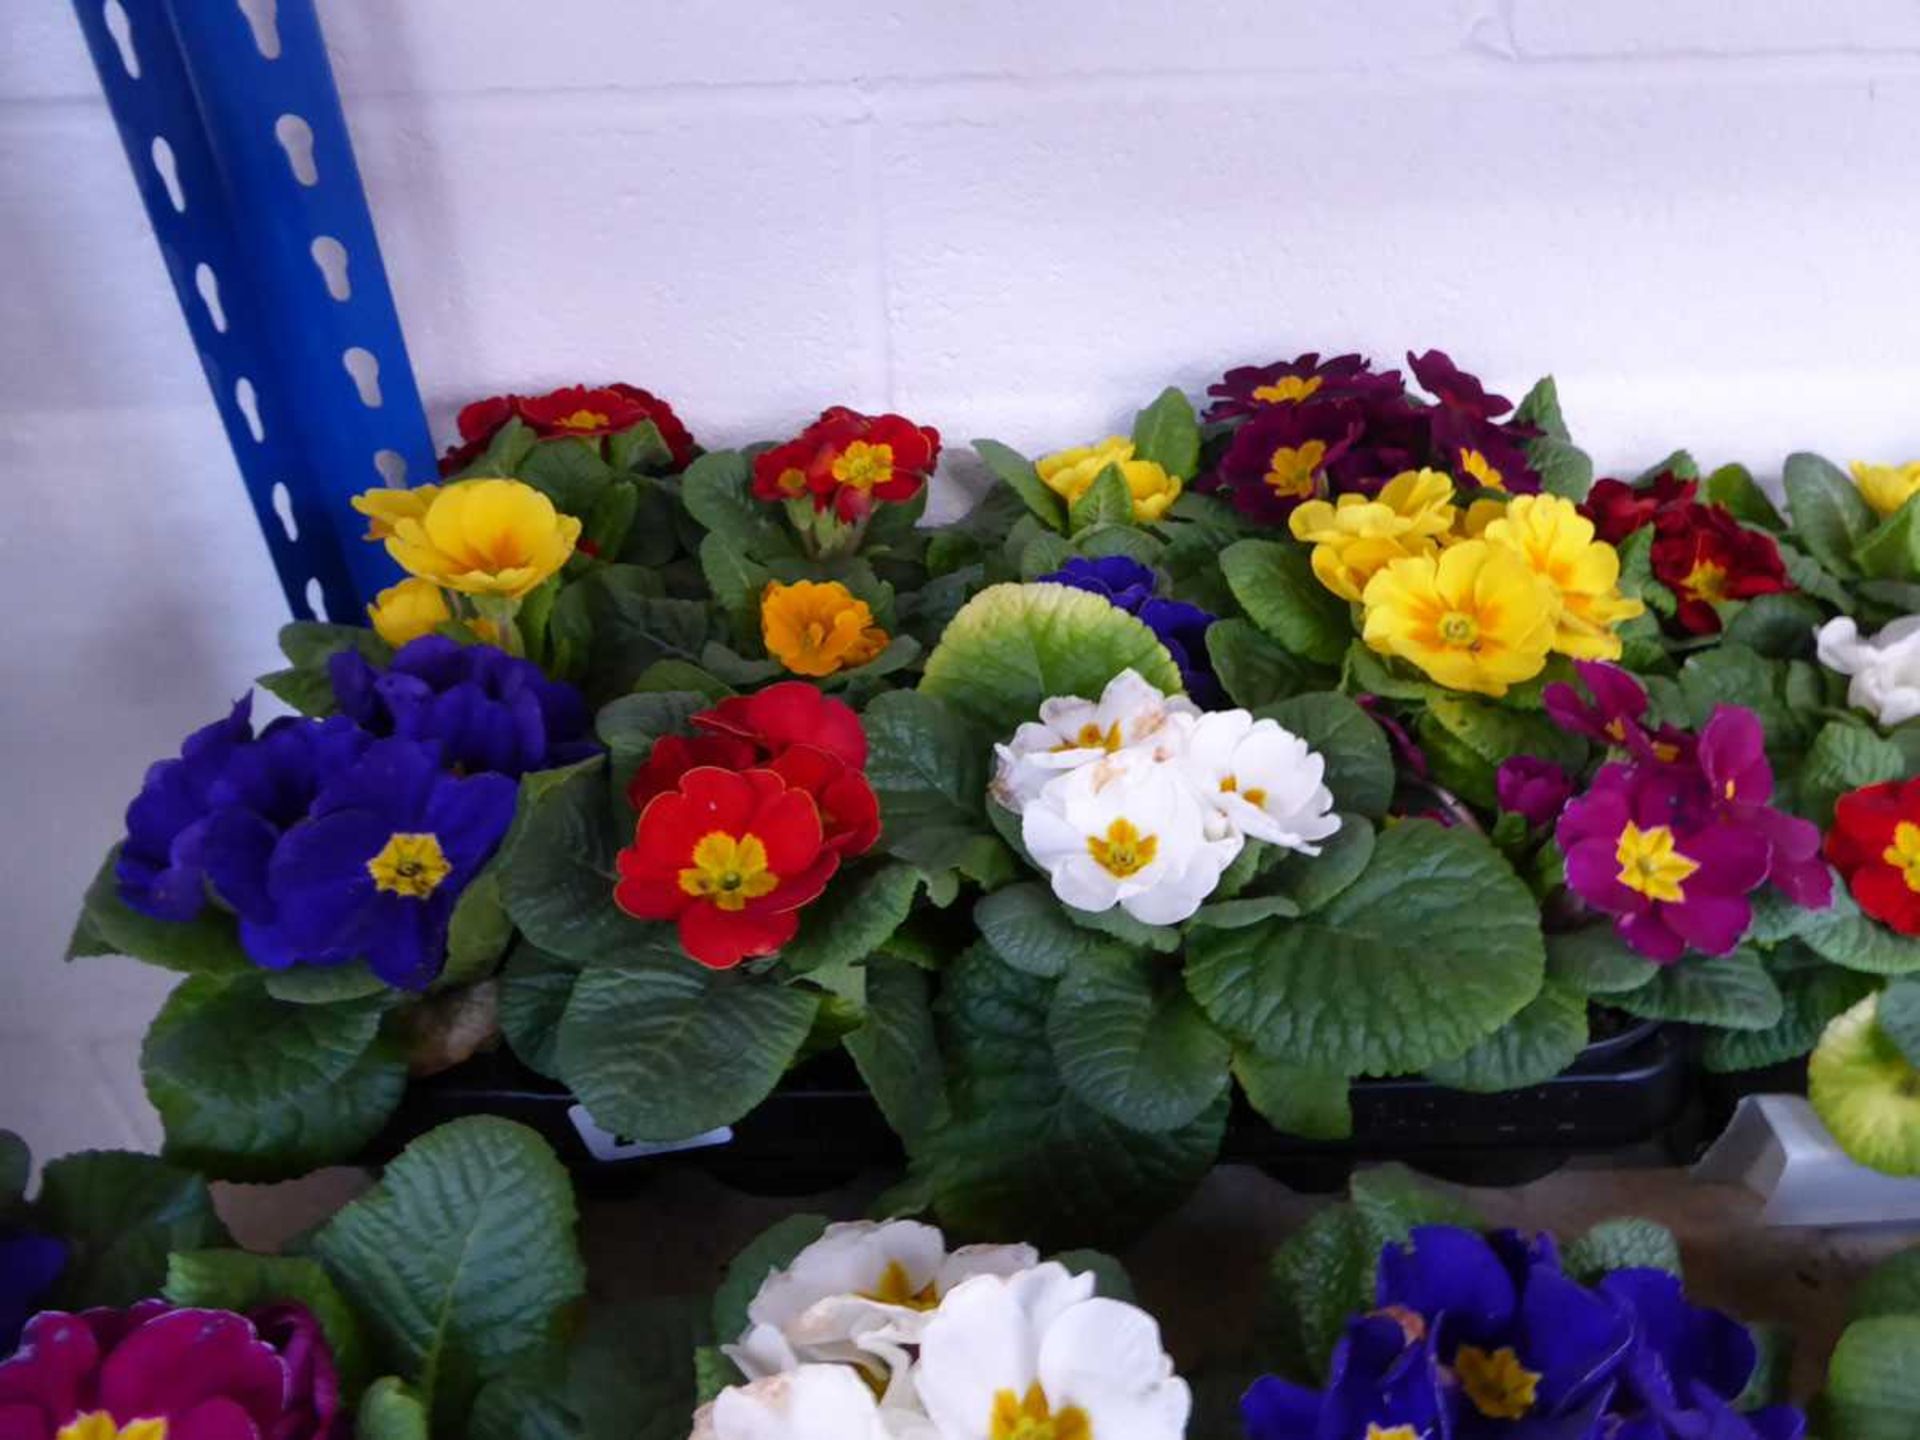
1240,1315,1453,1440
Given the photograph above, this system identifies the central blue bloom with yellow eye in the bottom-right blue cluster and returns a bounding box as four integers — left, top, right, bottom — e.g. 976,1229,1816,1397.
1377,1225,1634,1440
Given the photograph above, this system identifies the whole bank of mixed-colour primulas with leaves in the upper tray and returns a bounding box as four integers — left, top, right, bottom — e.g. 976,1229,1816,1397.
75,351,1920,1221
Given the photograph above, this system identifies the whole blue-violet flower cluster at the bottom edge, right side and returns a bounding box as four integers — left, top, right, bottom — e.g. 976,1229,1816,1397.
1240,1225,1807,1440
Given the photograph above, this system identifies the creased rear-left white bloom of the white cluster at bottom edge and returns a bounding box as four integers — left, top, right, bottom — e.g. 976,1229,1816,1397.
722,1219,1039,1400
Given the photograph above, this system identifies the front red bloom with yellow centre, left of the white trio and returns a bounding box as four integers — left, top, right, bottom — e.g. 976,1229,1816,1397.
612,766,841,970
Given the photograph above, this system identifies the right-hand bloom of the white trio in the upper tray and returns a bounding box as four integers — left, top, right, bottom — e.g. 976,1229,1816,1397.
1185,710,1340,854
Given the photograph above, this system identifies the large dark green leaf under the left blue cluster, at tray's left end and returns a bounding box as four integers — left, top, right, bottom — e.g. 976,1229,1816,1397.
140,975,407,1181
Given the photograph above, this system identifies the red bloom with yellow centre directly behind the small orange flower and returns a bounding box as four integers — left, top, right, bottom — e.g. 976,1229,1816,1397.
753,405,941,520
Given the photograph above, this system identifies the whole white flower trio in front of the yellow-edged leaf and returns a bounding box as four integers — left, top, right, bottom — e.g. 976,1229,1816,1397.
993,670,1340,925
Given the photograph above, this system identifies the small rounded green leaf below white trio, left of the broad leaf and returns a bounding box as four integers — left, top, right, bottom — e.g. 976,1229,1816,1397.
1046,956,1229,1131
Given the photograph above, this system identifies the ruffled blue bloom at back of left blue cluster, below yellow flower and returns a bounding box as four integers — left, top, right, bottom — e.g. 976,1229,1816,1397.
326,636,599,778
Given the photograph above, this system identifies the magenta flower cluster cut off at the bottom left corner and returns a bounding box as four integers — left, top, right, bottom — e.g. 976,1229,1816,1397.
0,1300,351,1440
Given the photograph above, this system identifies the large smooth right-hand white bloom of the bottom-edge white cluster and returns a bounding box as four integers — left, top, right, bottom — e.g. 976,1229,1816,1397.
914,1263,1192,1440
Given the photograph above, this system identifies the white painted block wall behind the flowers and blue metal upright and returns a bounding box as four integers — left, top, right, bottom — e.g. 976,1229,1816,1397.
0,0,1920,1152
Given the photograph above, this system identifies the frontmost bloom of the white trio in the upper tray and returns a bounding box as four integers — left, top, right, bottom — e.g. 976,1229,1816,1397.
1020,751,1244,925
